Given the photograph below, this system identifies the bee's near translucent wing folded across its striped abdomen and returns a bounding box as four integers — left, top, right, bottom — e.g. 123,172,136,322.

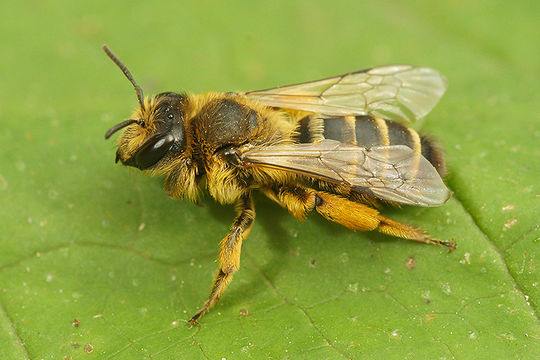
241,140,450,206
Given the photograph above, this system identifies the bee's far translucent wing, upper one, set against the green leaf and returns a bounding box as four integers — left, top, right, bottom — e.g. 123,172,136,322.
240,65,447,122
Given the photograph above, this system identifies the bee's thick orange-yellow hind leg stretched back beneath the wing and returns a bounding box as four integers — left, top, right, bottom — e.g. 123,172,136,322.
263,184,455,249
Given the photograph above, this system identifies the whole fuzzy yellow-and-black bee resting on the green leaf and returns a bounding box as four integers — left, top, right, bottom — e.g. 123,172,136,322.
103,46,455,324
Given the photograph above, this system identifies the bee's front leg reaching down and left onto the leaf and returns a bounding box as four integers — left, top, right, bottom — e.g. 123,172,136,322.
189,193,255,324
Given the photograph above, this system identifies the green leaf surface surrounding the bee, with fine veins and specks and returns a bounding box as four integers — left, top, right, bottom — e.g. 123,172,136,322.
0,0,540,359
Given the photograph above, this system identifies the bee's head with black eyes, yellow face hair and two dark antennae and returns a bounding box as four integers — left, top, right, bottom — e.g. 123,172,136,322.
103,46,187,170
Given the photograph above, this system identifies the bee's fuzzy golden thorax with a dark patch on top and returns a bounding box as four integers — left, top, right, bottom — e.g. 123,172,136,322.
188,93,294,203
